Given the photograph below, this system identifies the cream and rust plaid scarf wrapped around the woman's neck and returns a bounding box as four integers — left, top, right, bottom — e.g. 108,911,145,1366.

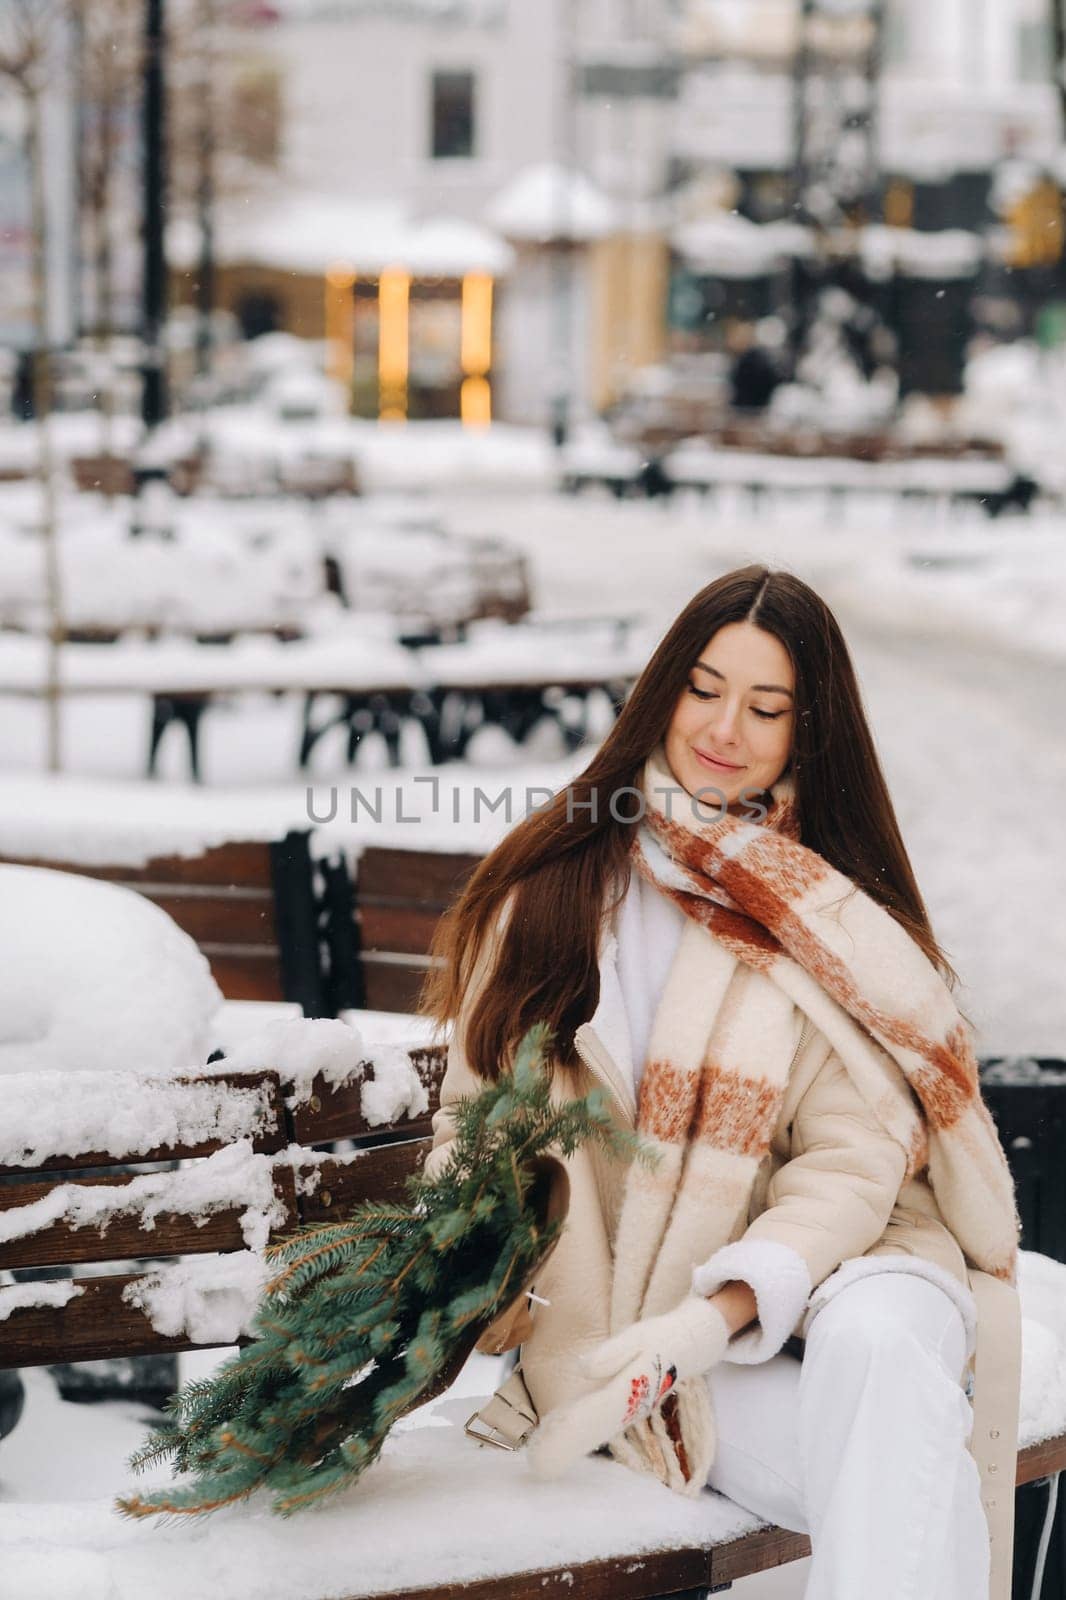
610,746,1020,1494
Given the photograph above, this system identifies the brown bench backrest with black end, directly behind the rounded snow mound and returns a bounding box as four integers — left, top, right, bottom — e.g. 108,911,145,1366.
0,830,352,1016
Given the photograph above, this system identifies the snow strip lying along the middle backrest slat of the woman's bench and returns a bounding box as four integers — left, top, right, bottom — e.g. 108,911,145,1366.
0,1139,287,1250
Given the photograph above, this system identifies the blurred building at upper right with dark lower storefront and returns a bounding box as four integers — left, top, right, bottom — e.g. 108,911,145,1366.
671,0,1066,394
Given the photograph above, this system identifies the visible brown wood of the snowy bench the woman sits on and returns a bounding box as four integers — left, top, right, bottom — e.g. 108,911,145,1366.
0,1050,1066,1600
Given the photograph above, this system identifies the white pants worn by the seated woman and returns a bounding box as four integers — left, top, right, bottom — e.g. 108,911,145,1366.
706,1272,989,1600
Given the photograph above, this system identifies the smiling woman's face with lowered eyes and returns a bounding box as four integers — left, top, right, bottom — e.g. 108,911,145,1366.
664,622,795,813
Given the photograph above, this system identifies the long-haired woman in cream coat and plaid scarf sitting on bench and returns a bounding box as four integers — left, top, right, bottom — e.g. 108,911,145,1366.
424,566,1020,1600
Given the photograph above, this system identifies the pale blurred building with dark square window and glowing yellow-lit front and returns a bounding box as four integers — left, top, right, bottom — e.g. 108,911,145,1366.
170,0,677,422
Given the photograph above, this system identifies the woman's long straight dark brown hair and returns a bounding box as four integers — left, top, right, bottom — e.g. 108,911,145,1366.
419,565,959,1080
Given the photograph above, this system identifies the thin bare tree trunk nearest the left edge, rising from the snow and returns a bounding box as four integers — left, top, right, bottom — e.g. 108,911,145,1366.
22,86,64,773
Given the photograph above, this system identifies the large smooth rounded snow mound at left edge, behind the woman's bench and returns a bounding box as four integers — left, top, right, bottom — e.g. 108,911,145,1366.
0,866,222,1081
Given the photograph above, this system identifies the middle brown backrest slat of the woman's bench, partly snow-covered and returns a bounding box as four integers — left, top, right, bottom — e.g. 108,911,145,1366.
0,1166,298,1273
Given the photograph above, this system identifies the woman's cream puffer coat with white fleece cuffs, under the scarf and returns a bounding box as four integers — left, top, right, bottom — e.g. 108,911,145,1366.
424,883,1021,1600
